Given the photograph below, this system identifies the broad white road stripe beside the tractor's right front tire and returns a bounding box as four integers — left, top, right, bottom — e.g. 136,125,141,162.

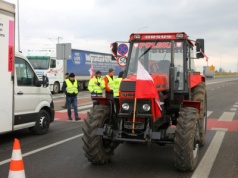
191,131,226,178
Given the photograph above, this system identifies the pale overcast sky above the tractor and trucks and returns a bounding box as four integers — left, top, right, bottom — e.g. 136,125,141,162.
6,0,238,71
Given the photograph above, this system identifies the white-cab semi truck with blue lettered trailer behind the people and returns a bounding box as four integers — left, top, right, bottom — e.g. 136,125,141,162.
27,49,122,93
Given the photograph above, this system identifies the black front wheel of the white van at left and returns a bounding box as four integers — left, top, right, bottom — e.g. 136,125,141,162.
33,110,50,135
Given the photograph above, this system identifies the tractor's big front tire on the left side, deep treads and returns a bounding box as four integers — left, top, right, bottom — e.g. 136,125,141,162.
82,105,115,164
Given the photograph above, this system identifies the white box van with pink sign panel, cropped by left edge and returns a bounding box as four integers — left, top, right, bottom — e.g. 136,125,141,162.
0,0,54,134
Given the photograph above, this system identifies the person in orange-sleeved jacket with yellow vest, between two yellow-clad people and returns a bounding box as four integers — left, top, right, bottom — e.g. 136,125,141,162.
104,68,115,99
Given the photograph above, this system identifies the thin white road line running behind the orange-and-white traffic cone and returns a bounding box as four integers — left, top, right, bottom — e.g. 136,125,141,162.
0,133,83,166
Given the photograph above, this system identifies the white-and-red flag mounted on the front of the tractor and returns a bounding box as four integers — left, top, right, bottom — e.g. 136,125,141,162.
135,62,161,117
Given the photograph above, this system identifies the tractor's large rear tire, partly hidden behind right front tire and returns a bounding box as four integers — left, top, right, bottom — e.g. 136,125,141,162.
192,82,207,146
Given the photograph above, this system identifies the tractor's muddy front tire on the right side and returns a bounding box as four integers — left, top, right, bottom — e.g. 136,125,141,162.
174,107,200,171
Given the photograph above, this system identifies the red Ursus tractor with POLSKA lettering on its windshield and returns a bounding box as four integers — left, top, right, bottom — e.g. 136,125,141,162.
83,32,207,171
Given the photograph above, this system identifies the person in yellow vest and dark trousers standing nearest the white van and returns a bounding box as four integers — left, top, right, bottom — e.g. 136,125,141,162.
62,73,81,121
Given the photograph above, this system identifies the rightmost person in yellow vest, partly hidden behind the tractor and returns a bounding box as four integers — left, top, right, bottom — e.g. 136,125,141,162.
113,71,124,113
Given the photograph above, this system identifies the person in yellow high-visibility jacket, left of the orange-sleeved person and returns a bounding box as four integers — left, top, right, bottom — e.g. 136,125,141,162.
88,71,105,106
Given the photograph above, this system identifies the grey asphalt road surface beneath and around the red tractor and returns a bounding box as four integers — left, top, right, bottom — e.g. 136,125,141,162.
0,78,238,178
